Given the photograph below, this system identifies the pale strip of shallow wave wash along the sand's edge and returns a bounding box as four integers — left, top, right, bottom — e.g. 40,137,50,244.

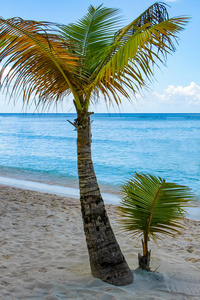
0,176,200,221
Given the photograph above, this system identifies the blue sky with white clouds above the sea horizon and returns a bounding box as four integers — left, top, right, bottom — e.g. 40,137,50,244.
0,0,200,113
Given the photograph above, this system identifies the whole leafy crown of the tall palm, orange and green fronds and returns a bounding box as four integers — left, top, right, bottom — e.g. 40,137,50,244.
0,3,188,111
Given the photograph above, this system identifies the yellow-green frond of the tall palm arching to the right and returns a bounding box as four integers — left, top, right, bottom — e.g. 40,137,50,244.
90,3,188,104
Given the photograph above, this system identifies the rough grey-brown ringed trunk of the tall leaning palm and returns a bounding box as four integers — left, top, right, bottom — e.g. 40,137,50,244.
74,112,133,286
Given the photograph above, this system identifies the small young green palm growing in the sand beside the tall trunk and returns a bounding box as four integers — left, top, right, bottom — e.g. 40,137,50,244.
118,173,194,270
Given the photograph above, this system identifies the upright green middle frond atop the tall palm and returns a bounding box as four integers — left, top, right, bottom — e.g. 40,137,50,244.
59,5,121,76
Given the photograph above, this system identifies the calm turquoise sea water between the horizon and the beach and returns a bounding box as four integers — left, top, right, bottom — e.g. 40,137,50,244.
0,114,200,198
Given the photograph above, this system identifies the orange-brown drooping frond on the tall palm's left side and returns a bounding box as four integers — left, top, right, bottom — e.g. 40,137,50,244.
0,18,84,109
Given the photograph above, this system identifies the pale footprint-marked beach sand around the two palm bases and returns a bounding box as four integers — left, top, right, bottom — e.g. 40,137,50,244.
0,186,200,300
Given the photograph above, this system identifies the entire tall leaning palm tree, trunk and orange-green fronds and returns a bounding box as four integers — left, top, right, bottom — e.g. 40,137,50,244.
0,3,187,285
